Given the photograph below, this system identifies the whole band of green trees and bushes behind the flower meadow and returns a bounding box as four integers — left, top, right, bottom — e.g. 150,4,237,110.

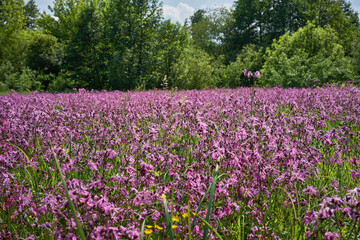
0,0,360,92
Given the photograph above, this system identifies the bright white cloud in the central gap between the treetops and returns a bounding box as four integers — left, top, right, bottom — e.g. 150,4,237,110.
163,2,195,23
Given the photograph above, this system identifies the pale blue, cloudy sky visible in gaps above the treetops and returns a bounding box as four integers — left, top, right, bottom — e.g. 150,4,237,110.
35,0,360,23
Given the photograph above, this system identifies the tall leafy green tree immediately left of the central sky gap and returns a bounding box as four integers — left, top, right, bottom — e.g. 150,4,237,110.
105,0,161,90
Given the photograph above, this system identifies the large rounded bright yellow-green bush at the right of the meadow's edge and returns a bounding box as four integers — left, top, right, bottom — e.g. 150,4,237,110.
261,23,354,87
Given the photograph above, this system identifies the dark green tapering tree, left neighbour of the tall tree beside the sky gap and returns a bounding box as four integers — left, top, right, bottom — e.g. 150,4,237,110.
65,1,108,89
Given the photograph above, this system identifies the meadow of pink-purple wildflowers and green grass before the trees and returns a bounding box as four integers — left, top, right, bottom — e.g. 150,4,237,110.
0,86,360,239
